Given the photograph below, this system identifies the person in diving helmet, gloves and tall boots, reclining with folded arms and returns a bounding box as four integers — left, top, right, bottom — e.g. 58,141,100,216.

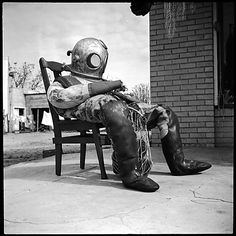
47,38,211,192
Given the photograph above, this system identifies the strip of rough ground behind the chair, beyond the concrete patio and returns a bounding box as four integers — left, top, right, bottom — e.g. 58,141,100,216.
3,131,94,167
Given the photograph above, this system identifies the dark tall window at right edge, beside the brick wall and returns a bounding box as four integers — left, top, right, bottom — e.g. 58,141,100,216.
216,2,235,107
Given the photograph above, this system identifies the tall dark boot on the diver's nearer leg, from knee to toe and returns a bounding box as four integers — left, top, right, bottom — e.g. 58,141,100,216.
101,101,159,192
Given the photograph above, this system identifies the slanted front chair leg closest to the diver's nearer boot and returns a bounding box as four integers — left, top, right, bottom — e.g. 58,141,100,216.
93,127,108,179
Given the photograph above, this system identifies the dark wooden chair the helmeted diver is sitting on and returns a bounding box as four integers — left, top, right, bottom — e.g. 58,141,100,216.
39,57,109,179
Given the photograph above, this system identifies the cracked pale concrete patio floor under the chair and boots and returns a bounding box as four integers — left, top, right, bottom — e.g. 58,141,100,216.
4,148,233,234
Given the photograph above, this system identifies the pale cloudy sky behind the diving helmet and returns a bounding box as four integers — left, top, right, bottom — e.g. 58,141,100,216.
2,2,150,89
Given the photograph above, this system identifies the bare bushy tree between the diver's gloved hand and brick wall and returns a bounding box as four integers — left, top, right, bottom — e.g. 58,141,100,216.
131,83,151,104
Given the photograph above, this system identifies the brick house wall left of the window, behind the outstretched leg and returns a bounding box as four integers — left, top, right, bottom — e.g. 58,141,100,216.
149,2,215,146
